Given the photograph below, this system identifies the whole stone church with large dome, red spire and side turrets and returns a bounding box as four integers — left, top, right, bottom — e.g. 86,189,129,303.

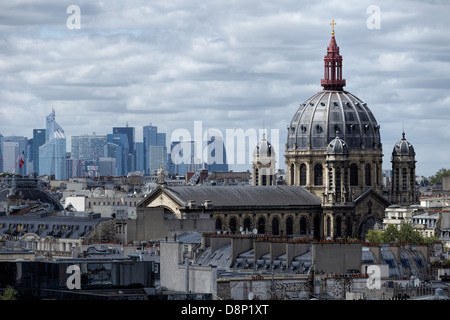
138,27,418,239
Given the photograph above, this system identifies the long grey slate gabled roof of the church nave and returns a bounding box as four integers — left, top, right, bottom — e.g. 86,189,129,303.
139,186,321,207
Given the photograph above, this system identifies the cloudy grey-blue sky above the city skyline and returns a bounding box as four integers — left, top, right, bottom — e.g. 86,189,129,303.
0,0,450,176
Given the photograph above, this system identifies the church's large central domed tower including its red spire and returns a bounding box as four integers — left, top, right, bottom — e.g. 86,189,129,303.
284,21,383,201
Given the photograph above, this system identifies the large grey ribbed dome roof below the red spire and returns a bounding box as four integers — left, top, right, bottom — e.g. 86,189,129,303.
287,90,381,150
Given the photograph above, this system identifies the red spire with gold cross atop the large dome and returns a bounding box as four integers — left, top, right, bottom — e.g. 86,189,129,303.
320,20,345,90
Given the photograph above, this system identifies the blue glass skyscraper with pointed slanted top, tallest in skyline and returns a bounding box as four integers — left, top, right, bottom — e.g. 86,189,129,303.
39,110,67,180
